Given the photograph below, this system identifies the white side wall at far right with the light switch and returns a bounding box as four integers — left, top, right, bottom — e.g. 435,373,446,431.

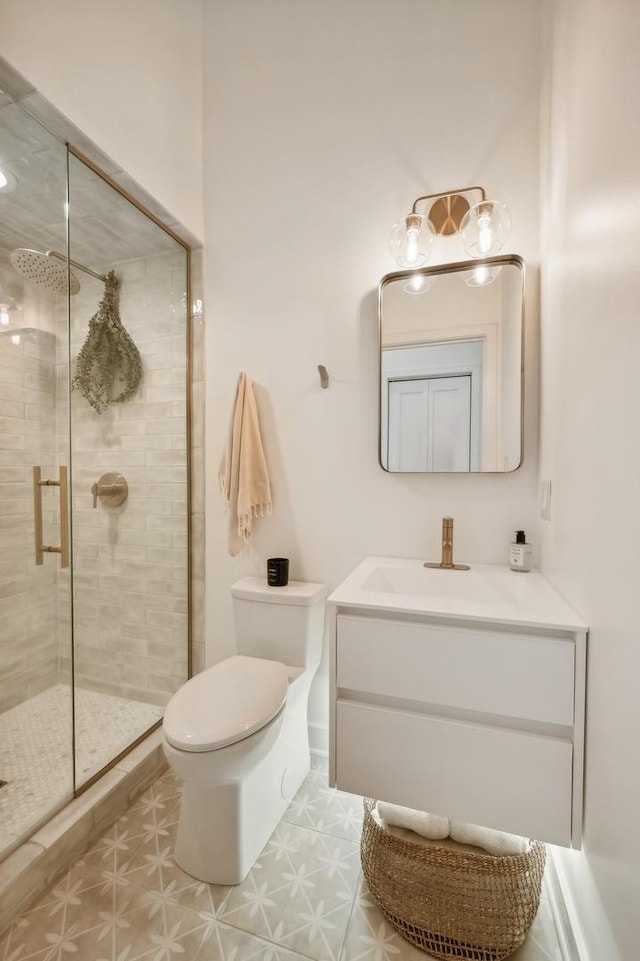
541,0,640,961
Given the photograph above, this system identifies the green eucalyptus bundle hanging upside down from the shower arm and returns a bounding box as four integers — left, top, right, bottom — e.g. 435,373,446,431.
72,270,142,414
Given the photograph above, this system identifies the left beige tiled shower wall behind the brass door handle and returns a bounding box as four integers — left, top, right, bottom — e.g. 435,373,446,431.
0,290,59,711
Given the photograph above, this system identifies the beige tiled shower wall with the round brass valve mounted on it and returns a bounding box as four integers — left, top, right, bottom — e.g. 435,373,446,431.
58,251,188,704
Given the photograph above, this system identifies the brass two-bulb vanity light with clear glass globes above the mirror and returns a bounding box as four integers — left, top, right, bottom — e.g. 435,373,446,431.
389,187,511,268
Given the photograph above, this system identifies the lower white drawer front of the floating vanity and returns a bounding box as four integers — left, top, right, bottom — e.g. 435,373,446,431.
335,701,573,845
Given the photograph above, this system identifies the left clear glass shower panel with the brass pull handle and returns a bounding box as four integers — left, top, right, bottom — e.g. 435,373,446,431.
0,93,74,856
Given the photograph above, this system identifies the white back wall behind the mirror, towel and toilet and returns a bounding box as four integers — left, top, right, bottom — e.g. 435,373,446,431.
204,0,540,744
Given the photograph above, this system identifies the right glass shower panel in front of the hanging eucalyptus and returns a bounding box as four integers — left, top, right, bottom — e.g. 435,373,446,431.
69,154,189,788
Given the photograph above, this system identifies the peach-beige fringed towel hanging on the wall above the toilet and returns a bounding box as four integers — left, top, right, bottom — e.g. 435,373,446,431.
218,373,271,556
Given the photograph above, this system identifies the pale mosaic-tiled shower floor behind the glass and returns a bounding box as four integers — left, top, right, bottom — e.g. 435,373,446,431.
0,684,163,855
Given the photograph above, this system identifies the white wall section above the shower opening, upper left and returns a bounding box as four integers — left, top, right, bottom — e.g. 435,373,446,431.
0,0,203,237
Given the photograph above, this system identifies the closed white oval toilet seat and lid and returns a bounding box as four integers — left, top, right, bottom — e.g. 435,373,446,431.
163,654,288,752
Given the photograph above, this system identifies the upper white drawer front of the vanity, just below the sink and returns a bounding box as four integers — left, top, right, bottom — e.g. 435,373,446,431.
336,614,575,725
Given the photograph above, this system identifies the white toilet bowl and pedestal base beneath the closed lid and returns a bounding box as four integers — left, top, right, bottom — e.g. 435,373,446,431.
169,708,310,884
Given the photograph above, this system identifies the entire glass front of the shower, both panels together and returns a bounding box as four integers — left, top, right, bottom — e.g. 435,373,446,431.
0,93,190,857
